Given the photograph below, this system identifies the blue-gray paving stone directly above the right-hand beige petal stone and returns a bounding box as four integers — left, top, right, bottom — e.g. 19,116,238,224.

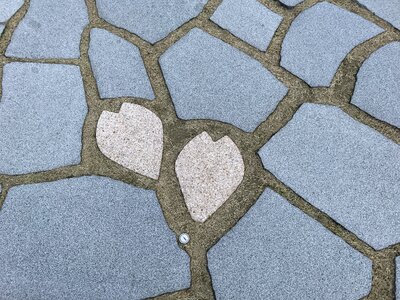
160,29,287,131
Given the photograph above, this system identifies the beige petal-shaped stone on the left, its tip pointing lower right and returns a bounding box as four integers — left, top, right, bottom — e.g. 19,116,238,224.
96,103,163,179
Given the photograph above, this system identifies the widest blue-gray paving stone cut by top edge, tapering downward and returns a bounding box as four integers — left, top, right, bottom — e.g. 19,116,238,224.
96,0,207,43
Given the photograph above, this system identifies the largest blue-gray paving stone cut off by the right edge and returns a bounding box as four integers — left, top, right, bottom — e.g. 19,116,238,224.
259,104,400,249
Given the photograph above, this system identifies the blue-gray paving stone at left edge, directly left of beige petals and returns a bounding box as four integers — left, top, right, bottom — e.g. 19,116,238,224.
0,63,87,174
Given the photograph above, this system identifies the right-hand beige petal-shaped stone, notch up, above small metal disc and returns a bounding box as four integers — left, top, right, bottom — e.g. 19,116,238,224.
175,132,244,222
